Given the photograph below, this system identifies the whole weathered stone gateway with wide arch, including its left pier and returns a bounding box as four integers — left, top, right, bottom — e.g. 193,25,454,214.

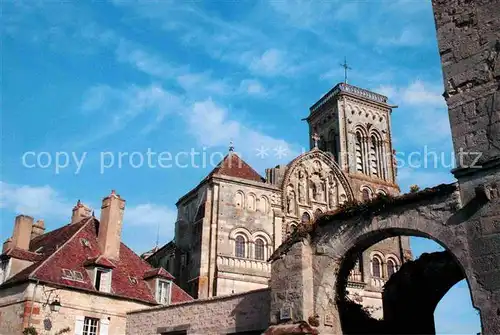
270,184,497,334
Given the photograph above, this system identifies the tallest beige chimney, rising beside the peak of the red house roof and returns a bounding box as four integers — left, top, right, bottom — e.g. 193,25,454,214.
97,190,125,259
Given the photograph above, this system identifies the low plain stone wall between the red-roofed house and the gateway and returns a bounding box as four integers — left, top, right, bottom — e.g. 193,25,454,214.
126,289,270,335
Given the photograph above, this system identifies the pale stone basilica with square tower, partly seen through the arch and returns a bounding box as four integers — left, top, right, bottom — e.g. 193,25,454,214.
146,83,412,316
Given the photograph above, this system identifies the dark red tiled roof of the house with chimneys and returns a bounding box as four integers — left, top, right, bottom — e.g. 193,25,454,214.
0,217,193,304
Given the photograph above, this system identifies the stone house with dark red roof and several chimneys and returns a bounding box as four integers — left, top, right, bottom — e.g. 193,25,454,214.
0,191,192,335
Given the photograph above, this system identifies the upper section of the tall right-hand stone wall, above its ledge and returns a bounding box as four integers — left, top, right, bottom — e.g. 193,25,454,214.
433,0,500,166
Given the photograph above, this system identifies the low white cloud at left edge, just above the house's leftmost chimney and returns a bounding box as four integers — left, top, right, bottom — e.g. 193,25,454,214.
0,181,76,220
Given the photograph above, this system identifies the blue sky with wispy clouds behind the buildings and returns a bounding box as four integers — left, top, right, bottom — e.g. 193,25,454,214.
0,0,479,333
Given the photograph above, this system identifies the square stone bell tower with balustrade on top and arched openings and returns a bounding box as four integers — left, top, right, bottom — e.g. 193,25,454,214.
306,83,399,197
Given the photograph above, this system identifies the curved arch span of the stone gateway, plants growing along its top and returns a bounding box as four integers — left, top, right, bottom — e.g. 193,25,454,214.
311,185,488,333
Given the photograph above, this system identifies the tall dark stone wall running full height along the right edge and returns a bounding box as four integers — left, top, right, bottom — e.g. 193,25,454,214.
432,0,500,334
